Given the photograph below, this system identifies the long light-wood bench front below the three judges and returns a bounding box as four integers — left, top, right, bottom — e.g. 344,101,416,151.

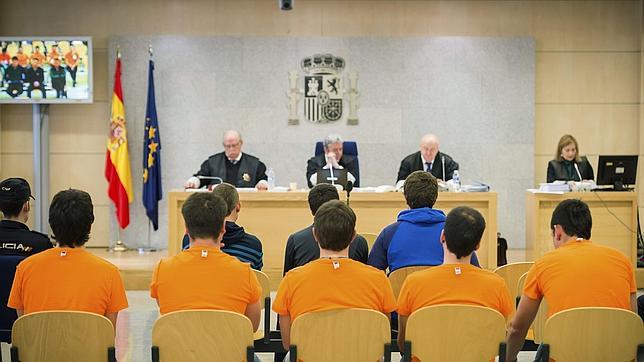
168,191,497,290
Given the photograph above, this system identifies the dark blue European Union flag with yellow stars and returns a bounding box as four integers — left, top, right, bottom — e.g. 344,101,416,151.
143,59,163,230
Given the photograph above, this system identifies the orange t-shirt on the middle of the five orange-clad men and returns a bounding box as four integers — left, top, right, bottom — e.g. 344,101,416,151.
273,258,396,320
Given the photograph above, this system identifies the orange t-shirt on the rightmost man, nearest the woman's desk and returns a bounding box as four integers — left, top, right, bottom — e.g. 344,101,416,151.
523,240,637,317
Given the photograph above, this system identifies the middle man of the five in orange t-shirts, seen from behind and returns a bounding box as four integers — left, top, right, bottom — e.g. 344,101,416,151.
273,200,396,350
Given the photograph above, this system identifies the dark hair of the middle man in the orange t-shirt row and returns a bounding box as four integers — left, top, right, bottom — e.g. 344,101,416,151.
313,200,356,251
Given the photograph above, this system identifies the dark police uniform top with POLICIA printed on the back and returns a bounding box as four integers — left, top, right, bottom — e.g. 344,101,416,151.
0,220,53,256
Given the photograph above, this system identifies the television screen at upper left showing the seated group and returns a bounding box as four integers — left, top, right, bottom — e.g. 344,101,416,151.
0,36,93,103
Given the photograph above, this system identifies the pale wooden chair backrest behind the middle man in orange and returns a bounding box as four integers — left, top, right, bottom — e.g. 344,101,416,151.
291,308,391,362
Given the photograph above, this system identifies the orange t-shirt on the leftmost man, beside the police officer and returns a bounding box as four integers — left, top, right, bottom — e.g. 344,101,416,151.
7,247,127,315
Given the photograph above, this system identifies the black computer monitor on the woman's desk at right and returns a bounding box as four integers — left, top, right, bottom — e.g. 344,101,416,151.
597,155,637,191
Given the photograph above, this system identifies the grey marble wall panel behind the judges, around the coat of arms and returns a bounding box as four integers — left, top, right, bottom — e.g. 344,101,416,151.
108,36,535,248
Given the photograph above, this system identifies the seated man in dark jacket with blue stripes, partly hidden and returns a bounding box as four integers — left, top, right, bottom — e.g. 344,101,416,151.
183,183,264,270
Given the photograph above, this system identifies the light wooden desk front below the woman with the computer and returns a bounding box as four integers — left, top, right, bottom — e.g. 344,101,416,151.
526,191,644,288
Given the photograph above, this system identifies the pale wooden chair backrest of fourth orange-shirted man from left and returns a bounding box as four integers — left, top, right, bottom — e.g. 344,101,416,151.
405,304,505,362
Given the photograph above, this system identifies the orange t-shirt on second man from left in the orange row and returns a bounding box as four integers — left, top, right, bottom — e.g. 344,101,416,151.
150,246,262,314
